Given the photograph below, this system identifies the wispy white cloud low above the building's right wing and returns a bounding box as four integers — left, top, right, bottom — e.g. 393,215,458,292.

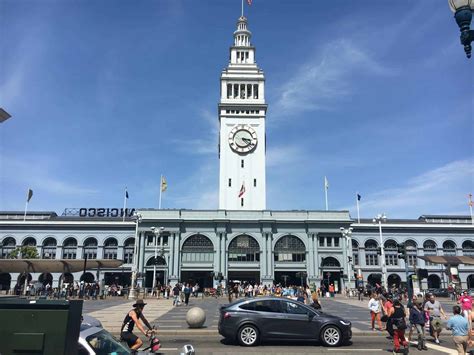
343,159,474,218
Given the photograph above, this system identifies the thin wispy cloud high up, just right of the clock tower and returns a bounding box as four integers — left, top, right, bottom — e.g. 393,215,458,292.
274,39,395,116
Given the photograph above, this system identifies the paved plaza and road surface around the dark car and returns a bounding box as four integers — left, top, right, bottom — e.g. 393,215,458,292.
80,296,466,354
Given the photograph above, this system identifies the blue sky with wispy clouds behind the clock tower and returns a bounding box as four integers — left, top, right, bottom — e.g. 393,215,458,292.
0,0,474,218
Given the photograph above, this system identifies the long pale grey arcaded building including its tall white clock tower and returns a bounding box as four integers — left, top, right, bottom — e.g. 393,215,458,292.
0,17,474,290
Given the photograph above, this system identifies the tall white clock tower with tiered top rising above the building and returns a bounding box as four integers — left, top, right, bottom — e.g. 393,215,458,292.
219,16,267,210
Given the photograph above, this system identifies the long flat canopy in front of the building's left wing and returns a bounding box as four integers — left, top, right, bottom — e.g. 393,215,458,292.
0,259,123,273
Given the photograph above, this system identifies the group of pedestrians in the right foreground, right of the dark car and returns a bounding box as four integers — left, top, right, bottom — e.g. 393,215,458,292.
368,287,474,355
